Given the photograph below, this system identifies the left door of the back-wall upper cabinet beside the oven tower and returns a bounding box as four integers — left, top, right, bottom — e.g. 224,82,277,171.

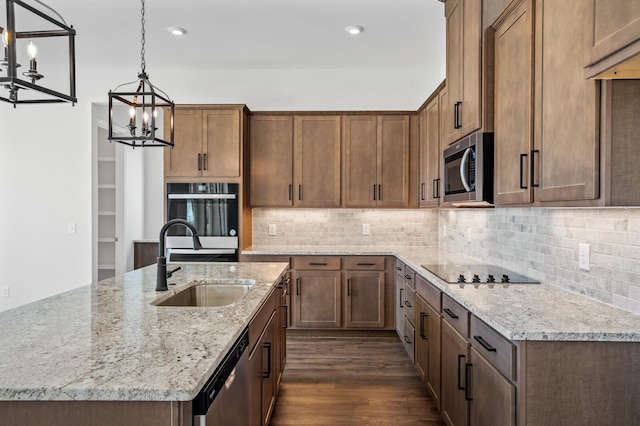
249,116,293,207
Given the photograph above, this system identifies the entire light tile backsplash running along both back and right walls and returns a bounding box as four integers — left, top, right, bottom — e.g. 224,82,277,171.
253,208,640,314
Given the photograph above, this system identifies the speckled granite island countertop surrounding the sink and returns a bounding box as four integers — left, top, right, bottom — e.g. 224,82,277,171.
0,263,288,401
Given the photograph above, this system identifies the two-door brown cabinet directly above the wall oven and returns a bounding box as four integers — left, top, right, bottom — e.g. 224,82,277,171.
164,105,244,178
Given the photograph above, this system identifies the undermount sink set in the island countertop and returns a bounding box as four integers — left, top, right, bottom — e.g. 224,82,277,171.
151,280,255,307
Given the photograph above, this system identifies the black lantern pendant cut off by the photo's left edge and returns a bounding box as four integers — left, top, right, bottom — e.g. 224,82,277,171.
0,0,78,107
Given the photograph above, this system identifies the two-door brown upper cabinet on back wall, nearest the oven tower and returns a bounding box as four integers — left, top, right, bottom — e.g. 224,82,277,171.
250,115,341,207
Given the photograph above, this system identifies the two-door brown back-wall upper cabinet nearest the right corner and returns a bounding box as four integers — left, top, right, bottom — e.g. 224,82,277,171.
342,114,409,207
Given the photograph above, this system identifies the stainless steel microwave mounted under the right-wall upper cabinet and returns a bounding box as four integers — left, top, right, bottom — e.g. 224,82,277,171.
443,132,493,206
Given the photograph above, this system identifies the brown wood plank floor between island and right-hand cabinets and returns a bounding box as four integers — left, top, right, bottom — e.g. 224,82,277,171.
271,335,444,426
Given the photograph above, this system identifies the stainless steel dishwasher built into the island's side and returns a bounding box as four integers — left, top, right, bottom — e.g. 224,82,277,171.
193,330,249,426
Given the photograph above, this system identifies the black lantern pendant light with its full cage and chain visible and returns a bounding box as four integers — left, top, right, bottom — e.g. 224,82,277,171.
108,0,175,148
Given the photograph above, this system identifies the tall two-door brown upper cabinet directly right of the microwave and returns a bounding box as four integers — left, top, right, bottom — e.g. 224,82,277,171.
493,0,599,204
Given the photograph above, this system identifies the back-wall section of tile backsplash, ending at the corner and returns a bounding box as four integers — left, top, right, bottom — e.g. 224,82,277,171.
253,209,438,246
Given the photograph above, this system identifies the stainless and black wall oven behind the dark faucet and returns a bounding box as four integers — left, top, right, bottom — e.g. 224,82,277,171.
166,183,239,262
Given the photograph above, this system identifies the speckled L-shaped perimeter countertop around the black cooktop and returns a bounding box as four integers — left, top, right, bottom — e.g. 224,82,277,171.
242,246,640,342
